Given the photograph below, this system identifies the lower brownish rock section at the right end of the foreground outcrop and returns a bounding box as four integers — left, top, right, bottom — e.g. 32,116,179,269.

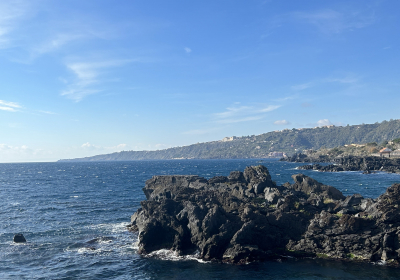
287,184,400,263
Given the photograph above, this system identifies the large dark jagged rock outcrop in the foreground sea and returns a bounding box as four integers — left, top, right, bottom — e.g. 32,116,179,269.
129,165,400,265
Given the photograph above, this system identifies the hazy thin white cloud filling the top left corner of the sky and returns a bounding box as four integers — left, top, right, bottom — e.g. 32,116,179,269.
0,0,134,64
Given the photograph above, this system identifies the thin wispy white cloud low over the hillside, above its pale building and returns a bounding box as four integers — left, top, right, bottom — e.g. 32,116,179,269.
214,104,281,124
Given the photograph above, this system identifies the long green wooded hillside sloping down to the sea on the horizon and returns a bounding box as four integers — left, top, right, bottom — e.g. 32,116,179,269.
60,120,400,161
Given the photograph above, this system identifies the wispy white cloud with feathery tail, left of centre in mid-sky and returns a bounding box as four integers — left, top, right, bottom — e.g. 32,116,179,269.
61,59,134,102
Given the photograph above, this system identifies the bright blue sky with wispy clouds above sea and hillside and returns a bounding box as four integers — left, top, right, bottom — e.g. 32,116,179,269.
0,0,400,162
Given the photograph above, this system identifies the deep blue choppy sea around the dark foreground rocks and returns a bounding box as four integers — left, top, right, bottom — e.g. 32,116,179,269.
0,159,400,279
